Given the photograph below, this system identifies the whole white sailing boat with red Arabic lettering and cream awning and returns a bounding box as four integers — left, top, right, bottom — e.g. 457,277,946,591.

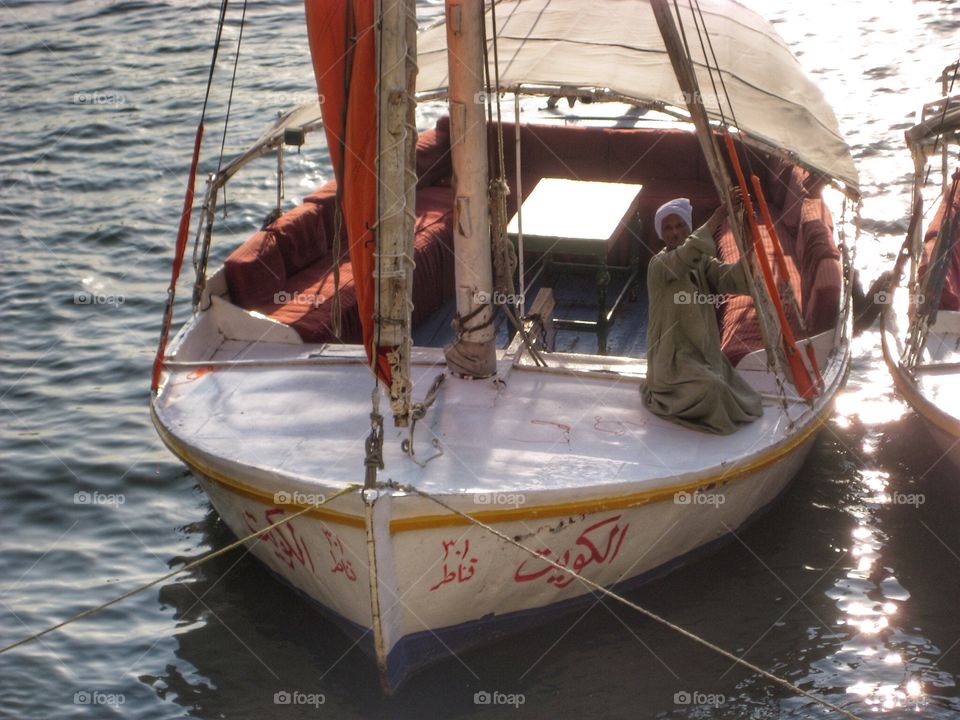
152,0,857,689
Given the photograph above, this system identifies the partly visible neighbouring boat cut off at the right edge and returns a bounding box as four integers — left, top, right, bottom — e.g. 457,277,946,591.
874,62,960,476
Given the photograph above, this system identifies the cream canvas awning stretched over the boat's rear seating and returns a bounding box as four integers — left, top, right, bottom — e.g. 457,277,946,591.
417,0,859,192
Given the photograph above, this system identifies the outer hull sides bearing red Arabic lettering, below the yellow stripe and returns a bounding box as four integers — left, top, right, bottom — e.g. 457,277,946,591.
189,434,814,689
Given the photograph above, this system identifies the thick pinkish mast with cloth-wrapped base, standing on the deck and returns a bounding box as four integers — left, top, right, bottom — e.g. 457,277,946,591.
444,0,497,377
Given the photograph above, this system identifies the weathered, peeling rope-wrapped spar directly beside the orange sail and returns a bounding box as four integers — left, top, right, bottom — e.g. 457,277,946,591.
374,0,417,427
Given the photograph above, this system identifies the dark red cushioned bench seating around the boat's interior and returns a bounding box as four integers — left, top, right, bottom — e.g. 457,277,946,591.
225,117,841,362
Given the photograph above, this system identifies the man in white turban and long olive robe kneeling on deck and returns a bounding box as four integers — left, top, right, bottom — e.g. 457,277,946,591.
641,196,763,435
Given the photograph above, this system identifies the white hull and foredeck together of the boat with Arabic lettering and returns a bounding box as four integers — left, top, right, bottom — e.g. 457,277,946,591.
154,310,849,690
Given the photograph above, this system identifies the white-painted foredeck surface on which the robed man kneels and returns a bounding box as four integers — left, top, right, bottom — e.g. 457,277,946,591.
155,293,845,497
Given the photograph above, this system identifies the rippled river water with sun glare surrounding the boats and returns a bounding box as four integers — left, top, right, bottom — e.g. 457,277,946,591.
0,0,960,718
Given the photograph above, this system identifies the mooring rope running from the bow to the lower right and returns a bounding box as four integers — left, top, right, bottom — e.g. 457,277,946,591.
384,481,862,720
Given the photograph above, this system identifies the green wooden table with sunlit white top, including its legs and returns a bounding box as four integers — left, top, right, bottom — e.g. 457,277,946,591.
507,178,643,355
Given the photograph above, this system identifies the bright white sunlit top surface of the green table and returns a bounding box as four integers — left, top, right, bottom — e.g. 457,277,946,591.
507,178,643,240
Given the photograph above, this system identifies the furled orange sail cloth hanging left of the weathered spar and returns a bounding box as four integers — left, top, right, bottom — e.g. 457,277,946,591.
304,0,390,384
